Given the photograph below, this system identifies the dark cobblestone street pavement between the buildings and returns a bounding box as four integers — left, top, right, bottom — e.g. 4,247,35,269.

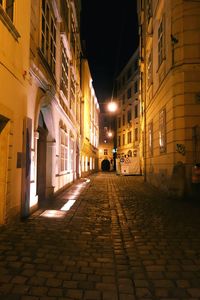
0,173,200,300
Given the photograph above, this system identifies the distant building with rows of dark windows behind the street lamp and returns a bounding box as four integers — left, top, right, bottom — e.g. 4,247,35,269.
116,50,142,170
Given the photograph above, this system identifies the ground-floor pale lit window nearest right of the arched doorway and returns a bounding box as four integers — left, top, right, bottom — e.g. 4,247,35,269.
60,128,68,172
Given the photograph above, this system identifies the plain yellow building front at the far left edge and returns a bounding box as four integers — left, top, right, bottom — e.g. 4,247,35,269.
0,0,31,224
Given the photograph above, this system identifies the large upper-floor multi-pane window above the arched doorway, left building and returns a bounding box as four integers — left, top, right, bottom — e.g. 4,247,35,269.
41,0,56,74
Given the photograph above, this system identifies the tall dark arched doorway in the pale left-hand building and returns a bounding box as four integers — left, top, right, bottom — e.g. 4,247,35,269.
37,112,48,207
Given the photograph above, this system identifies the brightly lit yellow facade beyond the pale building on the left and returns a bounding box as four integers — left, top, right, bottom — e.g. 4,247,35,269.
81,59,100,176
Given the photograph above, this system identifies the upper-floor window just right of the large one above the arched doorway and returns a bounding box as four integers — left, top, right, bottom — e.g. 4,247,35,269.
60,44,69,99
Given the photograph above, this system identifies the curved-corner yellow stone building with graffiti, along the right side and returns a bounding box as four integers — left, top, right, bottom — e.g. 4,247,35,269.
138,0,200,197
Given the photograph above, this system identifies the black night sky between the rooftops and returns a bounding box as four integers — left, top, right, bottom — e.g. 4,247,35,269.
81,0,138,102
